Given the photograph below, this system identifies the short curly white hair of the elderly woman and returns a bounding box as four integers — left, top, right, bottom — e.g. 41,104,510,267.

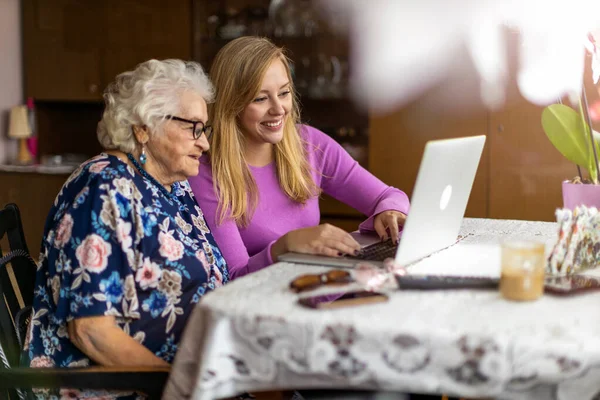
97,59,214,153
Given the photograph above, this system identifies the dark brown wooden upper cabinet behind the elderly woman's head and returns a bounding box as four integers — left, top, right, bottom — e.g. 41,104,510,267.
22,0,192,101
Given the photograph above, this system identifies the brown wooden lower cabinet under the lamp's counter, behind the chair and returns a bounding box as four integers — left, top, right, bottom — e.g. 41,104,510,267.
0,172,68,253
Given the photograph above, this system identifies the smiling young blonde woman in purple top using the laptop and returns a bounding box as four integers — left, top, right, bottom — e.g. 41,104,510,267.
189,37,409,277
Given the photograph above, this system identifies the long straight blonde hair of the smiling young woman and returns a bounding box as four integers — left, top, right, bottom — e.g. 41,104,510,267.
209,36,319,226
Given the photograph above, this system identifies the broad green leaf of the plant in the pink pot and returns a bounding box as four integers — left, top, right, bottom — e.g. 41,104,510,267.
542,104,600,181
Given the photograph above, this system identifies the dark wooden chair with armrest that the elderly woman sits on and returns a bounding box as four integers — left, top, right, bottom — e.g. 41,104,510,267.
0,204,169,400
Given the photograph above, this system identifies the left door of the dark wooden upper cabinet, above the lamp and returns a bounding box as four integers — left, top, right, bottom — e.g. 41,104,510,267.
22,0,104,100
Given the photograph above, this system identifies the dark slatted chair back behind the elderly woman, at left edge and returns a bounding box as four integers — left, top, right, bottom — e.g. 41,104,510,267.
0,204,37,368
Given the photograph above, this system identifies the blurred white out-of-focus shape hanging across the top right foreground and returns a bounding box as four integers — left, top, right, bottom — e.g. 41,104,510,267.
320,0,600,112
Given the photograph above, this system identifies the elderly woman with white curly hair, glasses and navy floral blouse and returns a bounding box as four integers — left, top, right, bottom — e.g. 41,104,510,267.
28,60,228,390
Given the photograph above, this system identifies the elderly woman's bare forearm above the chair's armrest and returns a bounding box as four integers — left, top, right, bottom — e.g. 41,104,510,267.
67,316,169,367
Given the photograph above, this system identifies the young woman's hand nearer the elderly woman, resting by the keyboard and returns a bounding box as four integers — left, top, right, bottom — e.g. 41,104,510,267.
271,224,360,260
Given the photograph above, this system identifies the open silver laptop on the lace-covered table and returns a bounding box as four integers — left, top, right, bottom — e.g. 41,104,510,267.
278,135,485,268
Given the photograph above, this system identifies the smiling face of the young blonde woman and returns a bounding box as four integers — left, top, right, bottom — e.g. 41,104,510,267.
239,59,292,153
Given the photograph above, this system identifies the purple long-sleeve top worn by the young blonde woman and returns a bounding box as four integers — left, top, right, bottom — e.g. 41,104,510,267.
189,125,409,278
